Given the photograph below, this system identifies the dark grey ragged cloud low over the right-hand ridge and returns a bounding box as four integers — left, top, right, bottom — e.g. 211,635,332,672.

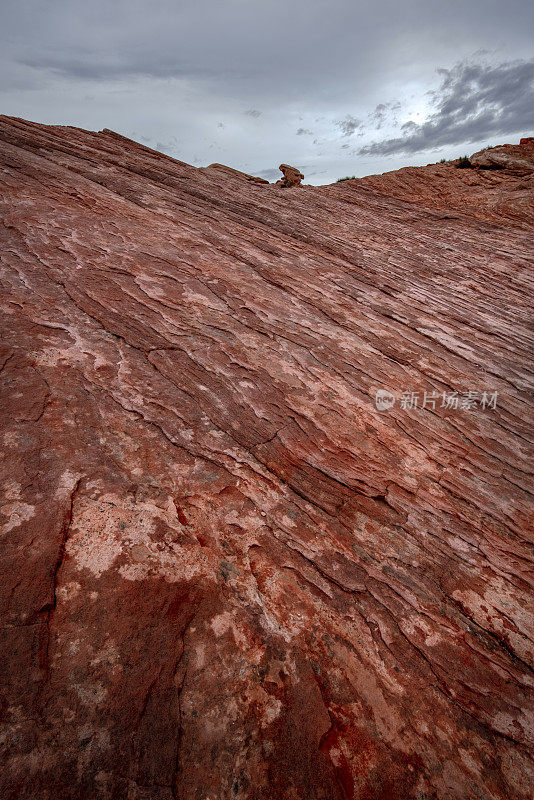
358,59,534,156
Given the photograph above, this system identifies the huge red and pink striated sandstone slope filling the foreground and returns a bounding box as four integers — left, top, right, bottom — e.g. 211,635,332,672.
0,117,533,800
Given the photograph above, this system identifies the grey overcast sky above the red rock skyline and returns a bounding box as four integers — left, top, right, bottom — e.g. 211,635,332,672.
0,0,534,184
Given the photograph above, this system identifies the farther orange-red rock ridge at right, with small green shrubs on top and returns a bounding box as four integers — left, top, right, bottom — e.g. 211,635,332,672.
330,138,534,230
